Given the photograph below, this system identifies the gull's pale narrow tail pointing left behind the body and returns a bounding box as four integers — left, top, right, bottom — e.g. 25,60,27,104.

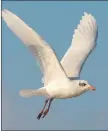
19,88,48,97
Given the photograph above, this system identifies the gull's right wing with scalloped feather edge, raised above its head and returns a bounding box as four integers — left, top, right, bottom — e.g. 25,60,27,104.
61,13,98,77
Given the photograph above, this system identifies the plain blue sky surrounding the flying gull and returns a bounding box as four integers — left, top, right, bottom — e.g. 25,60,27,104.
2,1,108,130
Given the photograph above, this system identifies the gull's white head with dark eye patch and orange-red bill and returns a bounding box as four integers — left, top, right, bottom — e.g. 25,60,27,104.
78,80,96,92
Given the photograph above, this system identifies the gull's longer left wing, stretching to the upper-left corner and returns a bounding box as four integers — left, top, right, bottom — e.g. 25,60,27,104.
2,10,66,85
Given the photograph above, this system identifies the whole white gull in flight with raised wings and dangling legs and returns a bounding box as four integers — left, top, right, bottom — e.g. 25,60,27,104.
2,9,98,119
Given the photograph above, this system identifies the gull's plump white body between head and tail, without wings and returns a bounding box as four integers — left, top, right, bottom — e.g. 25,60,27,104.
45,78,86,99
